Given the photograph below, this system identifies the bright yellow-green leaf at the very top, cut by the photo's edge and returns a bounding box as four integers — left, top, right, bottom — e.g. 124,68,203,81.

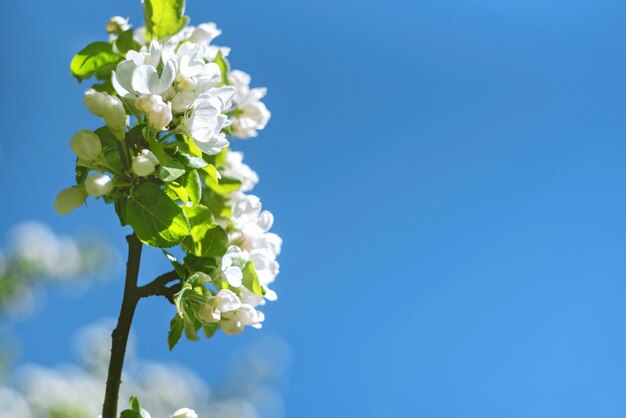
143,0,189,41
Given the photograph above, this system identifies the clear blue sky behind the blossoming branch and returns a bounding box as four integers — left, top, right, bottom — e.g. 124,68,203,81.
0,0,626,418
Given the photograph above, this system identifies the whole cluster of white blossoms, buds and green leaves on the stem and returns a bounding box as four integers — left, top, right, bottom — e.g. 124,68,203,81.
55,11,282,348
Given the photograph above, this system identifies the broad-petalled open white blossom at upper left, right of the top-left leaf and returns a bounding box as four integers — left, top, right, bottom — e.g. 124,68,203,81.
111,39,176,99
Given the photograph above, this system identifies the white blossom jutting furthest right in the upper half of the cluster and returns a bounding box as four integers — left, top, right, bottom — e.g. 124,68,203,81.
228,70,271,139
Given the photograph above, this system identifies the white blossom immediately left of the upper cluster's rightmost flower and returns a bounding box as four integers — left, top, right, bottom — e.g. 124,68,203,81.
184,87,234,155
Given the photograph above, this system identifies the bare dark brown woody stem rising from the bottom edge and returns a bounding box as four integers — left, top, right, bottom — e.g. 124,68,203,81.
102,234,142,418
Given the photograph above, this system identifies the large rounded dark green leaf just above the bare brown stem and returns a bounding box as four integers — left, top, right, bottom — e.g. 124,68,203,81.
126,183,191,248
